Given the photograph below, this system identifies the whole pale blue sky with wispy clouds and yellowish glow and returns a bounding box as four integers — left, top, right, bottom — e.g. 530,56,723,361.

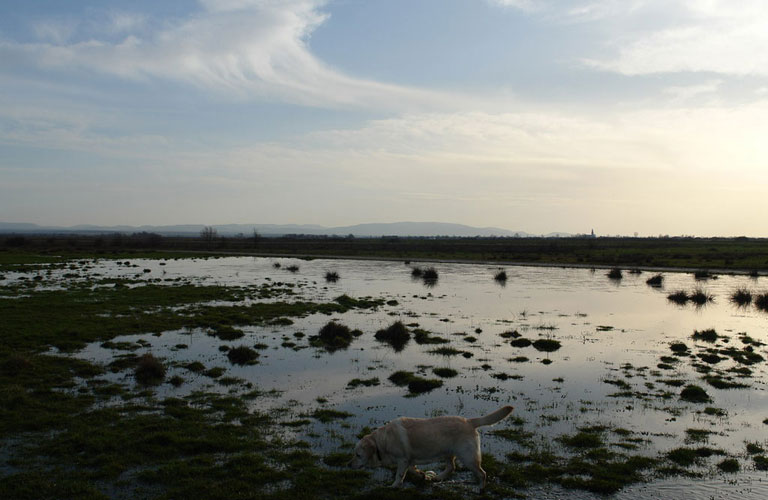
0,0,768,236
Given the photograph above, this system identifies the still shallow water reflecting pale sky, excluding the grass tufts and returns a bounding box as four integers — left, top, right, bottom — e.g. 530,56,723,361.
58,257,768,499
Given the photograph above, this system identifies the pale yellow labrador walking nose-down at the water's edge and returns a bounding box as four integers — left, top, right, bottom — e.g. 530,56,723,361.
349,406,512,491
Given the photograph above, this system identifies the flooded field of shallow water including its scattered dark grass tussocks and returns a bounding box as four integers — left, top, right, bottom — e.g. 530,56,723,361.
1,257,768,499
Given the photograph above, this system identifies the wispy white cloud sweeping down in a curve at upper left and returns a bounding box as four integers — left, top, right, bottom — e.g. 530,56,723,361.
0,0,455,108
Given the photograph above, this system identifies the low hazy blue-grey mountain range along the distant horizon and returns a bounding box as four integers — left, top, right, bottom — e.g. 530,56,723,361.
0,222,573,238
